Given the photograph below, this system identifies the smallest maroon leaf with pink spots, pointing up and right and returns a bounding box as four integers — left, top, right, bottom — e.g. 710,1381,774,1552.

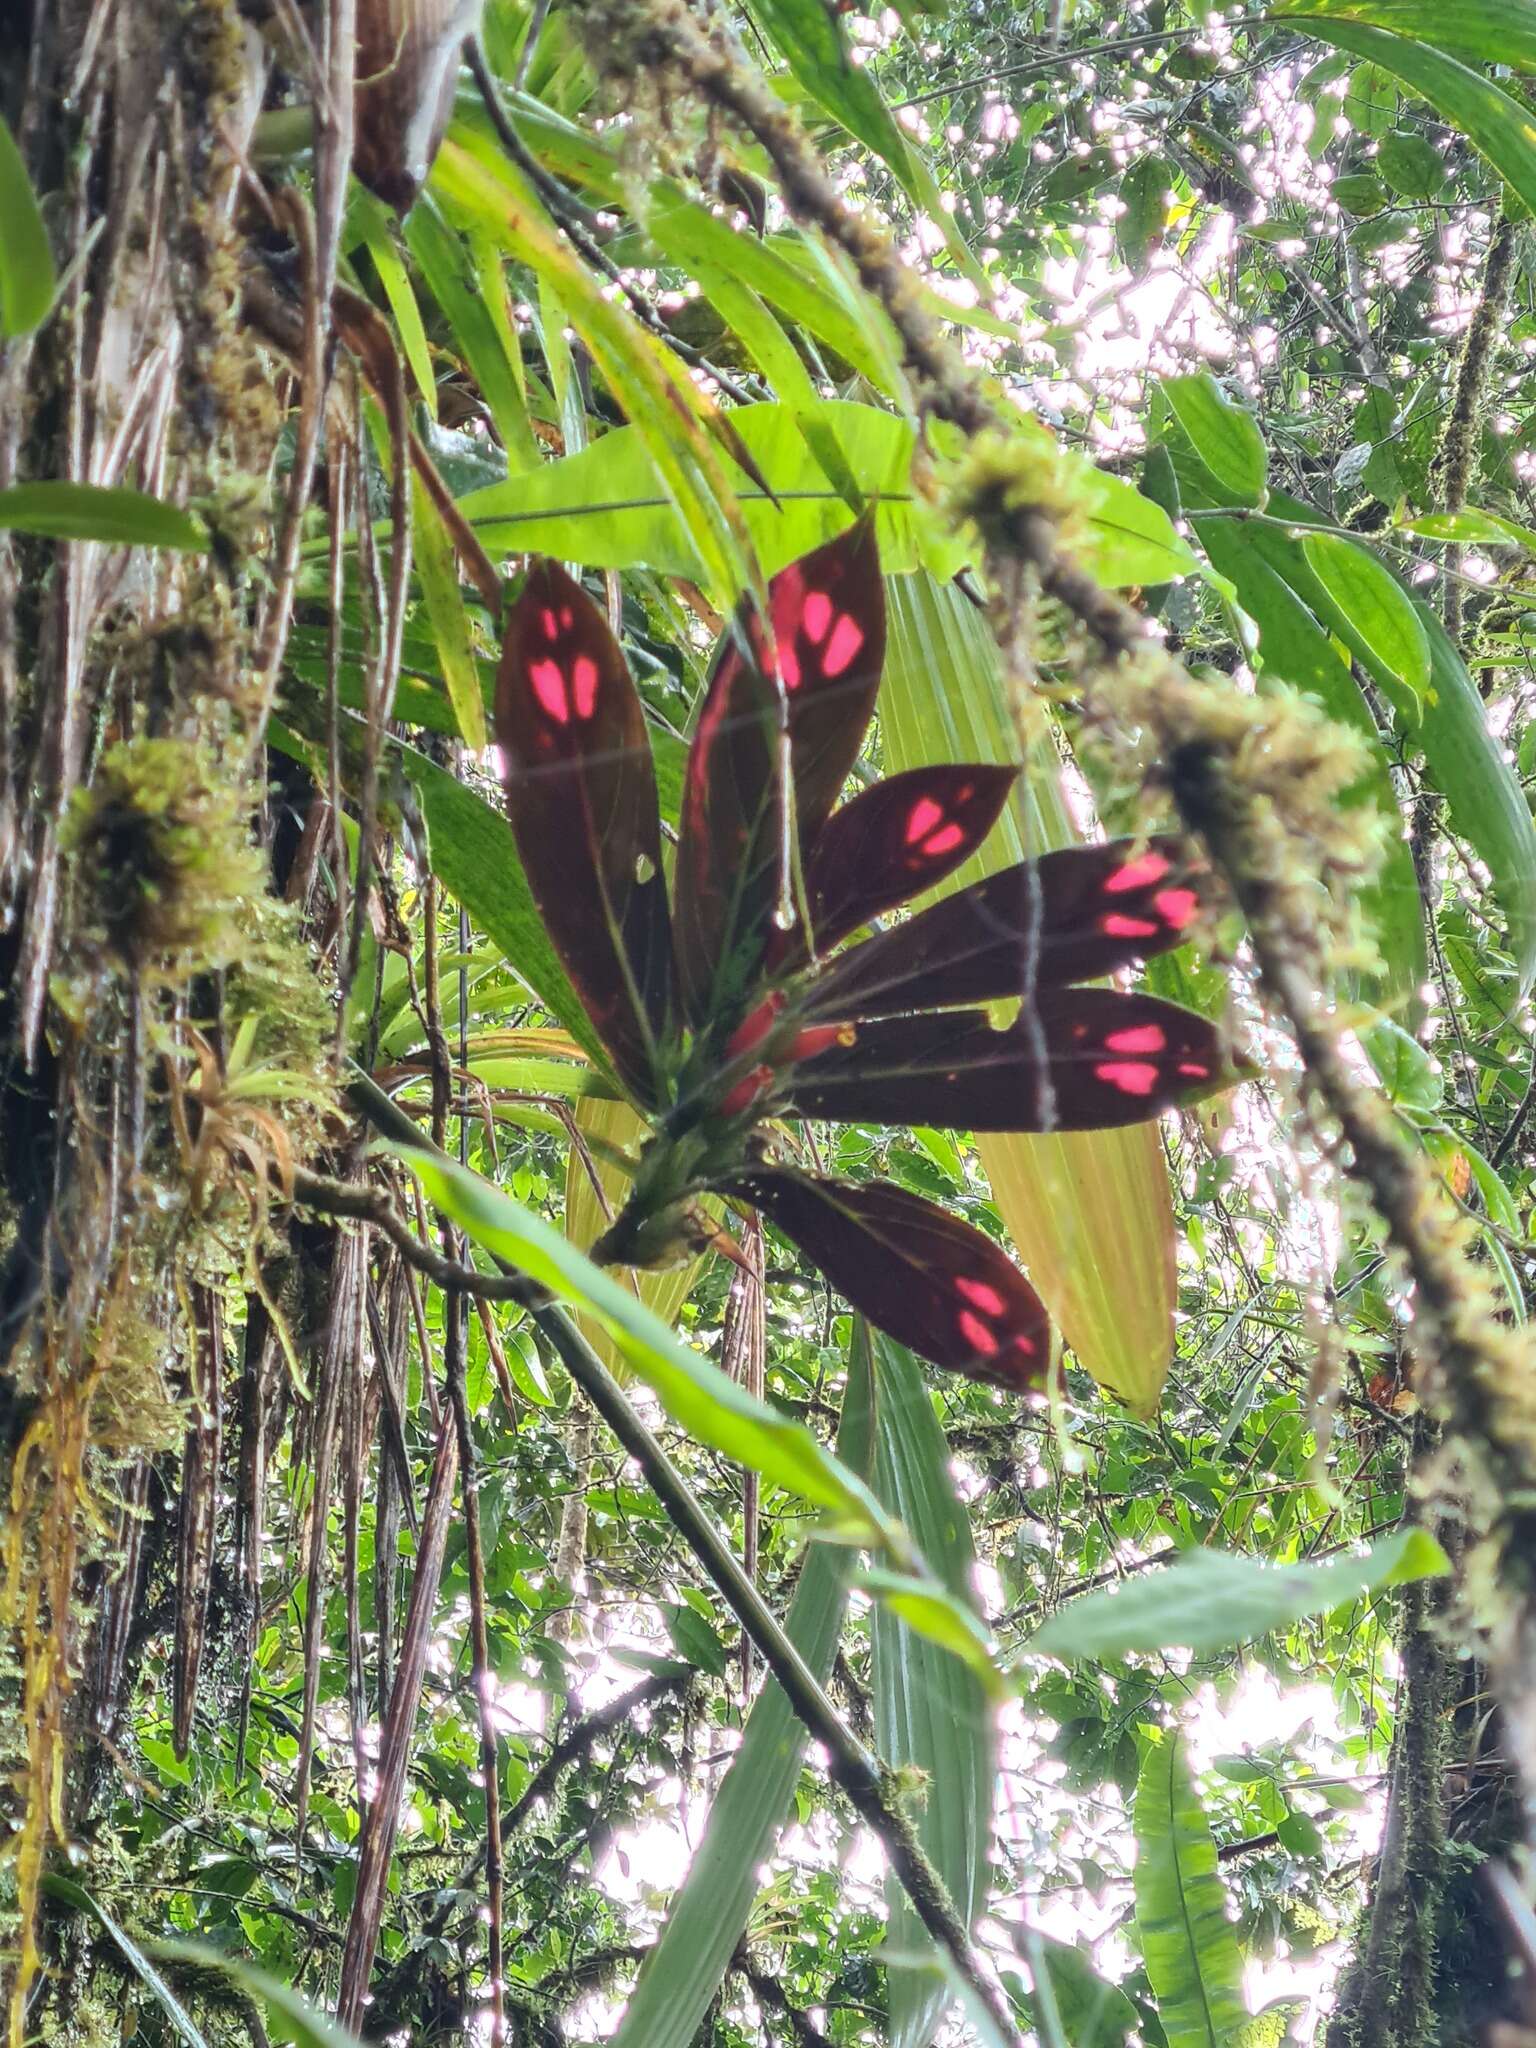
782,764,1018,952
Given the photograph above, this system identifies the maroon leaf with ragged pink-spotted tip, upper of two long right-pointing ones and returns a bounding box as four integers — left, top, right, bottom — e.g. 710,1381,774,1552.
807,831,1202,1018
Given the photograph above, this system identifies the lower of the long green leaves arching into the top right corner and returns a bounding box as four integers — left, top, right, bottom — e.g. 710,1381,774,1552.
1276,17,1536,213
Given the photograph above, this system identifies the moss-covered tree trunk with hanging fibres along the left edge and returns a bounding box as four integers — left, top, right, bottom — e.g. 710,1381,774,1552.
0,0,328,2044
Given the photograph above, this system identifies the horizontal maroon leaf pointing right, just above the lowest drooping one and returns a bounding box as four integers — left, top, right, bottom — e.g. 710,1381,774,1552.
788,989,1233,1130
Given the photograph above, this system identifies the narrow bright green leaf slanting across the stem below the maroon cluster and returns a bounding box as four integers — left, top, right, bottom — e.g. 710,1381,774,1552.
401,1151,893,1548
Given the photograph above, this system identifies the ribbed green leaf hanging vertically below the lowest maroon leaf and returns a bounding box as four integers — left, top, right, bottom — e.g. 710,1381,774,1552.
876,1319,995,2048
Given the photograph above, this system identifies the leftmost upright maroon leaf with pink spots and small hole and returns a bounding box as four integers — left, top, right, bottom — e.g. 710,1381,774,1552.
496,561,672,1106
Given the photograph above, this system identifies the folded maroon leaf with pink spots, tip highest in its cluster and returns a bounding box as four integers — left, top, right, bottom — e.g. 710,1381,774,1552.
676,520,885,1026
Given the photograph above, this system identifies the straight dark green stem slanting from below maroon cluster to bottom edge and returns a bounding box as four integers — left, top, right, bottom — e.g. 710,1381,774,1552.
348,1073,1022,2048
